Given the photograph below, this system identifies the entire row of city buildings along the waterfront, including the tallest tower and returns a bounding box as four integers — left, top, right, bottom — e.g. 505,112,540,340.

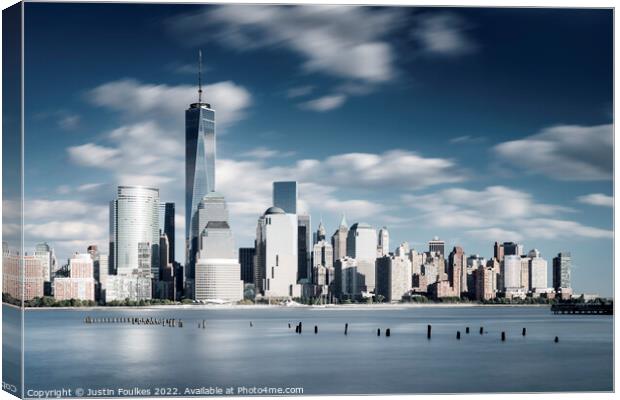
2,62,584,304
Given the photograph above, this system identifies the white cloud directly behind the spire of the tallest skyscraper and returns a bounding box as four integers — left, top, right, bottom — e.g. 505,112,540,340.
88,79,252,127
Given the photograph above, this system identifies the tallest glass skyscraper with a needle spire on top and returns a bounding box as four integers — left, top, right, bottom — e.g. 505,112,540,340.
185,52,215,289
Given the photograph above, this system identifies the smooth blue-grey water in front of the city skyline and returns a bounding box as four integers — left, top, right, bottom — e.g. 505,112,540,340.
14,307,613,394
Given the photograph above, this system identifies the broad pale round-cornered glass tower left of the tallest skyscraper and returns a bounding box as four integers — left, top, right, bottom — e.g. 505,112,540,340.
110,186,159,280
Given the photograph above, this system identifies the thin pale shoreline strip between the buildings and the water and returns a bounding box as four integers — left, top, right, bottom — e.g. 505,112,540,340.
2,303,551,311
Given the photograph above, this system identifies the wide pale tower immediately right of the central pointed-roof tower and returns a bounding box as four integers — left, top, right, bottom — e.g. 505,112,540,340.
347,222,377,293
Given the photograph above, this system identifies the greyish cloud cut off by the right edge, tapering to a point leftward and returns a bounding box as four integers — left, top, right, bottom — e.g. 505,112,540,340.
494,124,613,181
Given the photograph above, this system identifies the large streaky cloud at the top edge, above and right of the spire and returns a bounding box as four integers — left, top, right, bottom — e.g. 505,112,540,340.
169,5,402,82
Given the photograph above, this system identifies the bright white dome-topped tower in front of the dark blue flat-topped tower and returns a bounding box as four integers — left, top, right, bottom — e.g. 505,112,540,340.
256,207,301,298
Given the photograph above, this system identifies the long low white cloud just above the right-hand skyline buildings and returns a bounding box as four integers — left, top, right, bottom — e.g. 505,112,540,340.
402,186,612,241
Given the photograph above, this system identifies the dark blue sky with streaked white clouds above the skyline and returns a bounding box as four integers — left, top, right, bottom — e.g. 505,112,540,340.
25,3,613,294
